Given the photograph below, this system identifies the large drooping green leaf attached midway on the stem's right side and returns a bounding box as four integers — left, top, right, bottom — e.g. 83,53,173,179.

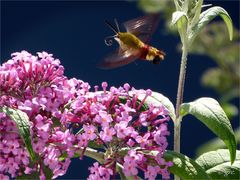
180,98,237,163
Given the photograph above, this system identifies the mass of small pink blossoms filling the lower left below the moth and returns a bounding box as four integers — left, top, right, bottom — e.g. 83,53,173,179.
0,51,172,179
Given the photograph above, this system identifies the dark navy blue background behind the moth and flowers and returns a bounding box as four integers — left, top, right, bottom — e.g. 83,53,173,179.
1,0,239,179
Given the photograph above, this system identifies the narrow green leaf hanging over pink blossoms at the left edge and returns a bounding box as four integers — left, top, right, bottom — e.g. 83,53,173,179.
0,106,36,161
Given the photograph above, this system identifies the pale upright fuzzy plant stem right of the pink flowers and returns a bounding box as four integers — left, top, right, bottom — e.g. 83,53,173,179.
174,42,188,180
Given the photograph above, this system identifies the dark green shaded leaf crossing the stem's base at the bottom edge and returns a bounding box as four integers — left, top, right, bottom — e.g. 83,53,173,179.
164,151,210,179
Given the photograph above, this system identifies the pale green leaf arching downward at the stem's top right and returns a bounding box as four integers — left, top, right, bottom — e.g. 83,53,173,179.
189,6,233,40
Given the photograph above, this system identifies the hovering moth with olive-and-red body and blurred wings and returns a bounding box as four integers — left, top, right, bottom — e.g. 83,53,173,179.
98,15,165,69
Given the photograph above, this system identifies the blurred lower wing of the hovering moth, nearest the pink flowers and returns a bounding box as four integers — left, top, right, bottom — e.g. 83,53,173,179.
98,49,140,69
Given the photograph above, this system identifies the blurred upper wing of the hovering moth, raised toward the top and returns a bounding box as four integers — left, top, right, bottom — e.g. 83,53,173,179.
123,14,159,43
